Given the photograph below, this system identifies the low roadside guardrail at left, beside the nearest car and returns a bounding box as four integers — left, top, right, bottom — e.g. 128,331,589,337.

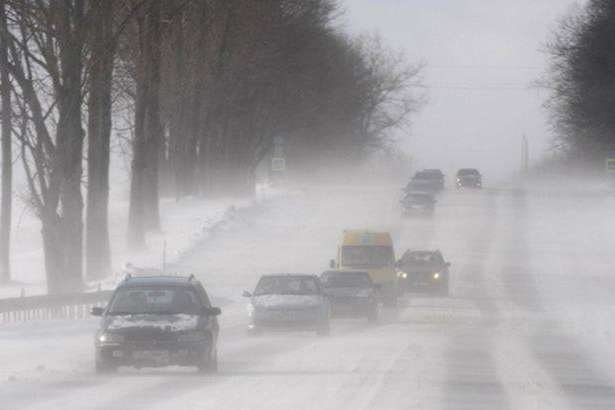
0,290,113,322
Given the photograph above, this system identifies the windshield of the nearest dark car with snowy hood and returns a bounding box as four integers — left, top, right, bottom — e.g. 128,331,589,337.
108,287,200,315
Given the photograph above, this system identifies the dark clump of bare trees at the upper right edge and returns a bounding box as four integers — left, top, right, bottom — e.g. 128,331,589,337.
544,0,615,165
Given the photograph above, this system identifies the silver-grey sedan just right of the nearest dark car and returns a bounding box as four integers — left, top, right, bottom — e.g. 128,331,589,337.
244,274,330,335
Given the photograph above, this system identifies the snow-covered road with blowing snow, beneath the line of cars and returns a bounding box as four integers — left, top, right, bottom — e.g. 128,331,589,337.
0,187,615,410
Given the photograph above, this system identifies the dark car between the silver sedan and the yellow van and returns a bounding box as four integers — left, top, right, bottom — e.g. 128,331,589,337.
320,270,380,322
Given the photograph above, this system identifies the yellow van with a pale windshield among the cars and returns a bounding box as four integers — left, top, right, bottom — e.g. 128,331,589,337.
330,230,399,306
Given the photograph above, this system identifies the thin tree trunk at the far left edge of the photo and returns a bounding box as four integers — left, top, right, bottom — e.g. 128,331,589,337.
0,0,13,283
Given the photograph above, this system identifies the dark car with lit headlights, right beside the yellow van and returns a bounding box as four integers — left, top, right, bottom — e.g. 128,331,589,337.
397,250,451,294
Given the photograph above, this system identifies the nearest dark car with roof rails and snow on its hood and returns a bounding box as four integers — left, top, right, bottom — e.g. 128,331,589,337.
91,276,220,373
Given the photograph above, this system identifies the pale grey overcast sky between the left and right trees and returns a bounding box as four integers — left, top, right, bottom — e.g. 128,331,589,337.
342,0,580,178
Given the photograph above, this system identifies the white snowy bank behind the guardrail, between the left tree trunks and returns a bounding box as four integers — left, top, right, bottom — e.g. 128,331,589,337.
0,185,283,298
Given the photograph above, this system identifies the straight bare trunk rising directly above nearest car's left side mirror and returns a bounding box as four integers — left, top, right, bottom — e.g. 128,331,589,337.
86,0,114,280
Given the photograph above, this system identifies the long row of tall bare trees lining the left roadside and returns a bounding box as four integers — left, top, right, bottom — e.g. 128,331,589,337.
0,0,420,293
